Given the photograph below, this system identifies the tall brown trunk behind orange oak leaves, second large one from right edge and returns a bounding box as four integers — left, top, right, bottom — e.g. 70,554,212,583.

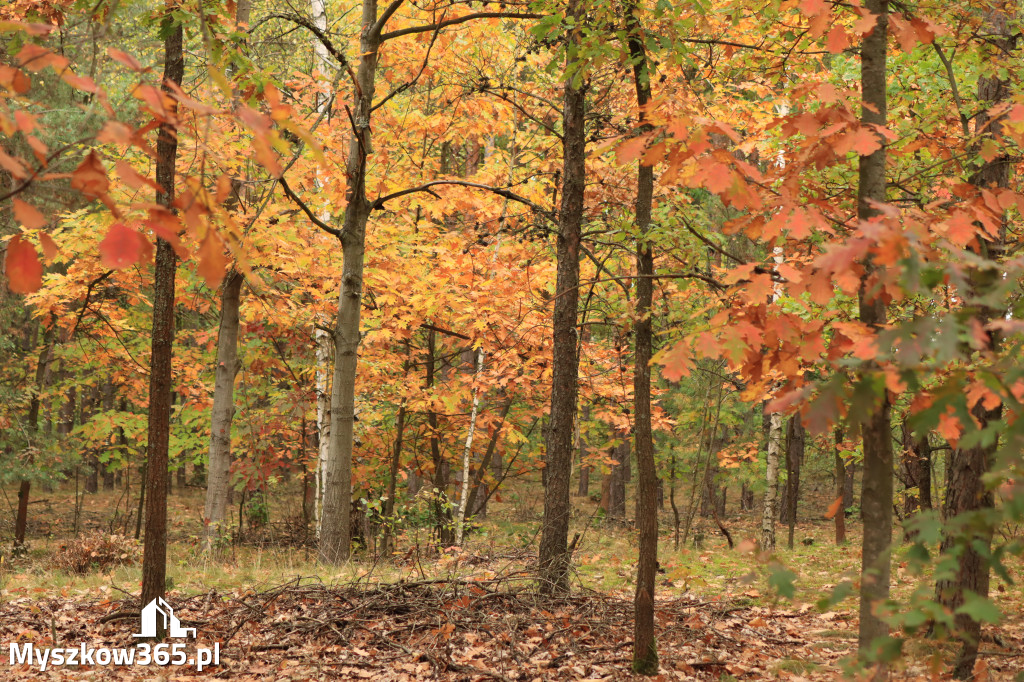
857,0,893,659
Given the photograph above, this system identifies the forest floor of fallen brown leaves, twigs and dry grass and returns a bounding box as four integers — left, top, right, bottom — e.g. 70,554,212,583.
0,481,1024,682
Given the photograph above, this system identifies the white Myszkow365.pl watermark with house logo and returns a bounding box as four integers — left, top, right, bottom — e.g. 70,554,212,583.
9,597,220,673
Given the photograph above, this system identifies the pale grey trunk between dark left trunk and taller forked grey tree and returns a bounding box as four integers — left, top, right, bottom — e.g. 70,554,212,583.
203,269,245,552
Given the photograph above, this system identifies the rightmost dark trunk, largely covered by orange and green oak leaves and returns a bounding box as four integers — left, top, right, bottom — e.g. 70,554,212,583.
935,3,1017,680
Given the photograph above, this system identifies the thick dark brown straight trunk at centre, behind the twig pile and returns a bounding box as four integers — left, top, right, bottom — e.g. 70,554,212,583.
538,0,587,595
